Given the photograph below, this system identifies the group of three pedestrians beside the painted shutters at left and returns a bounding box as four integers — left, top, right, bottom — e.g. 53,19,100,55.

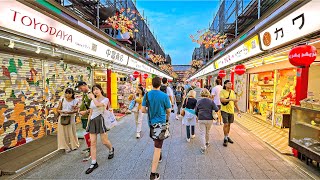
57,82,114,174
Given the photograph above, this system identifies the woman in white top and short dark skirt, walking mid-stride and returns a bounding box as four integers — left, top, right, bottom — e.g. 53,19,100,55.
86,84,114,174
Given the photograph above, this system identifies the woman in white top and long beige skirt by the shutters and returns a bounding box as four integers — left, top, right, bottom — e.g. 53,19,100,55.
58,88,79,152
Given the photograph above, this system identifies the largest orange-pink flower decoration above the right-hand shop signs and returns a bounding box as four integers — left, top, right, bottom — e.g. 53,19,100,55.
190,29,227,51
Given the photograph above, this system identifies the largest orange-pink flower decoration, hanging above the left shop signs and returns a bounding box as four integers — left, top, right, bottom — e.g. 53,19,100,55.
106,8,141,37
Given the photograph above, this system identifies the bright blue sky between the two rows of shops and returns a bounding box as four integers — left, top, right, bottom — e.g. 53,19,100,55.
136,0,219,65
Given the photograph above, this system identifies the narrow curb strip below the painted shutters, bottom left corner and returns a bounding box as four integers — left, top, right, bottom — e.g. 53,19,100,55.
7,150,63,179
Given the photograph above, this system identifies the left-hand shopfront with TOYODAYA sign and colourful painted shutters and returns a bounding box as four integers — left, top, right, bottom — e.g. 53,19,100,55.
0,0,170,152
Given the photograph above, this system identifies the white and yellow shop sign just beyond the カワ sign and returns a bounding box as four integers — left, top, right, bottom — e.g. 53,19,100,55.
214,35,262,69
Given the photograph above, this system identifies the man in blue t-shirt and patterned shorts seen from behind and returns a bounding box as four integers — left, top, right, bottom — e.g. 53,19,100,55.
142,77,171,180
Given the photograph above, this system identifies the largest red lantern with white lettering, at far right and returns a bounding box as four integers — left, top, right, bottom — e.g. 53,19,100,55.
289,45,317,67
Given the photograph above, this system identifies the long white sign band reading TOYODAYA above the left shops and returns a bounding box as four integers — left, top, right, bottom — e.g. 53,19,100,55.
0,0,128,65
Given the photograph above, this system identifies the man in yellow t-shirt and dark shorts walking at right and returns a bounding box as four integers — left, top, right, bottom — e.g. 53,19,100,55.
220,80,240,147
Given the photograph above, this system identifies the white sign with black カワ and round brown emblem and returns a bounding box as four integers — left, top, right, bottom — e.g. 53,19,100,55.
259,1,320,50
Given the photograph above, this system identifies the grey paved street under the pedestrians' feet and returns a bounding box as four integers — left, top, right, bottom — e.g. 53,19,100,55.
23,115,306,179
